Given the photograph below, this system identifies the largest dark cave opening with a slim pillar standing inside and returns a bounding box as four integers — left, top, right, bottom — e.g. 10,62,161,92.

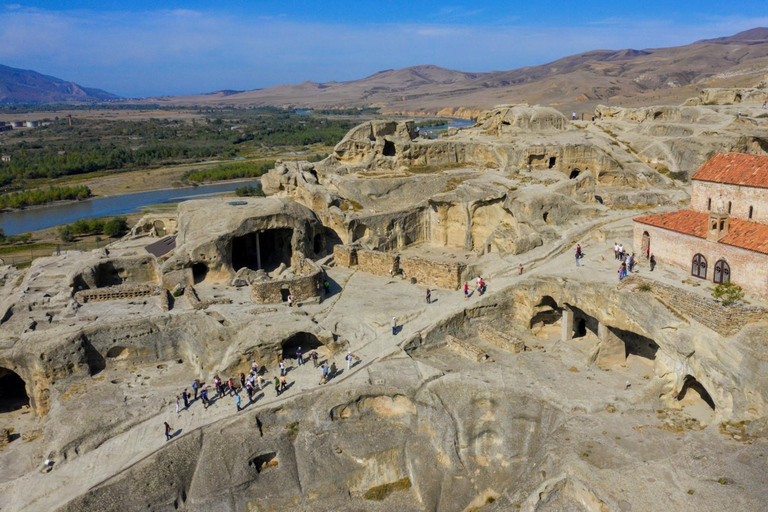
232,228,293,272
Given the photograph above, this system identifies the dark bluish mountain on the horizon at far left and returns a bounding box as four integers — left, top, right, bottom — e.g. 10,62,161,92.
0,65,118,104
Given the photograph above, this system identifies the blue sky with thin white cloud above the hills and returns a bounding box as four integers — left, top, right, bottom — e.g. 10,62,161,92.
0,0,768,97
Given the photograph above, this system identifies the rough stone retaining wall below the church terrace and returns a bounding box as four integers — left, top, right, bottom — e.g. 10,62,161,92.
619,276,768,336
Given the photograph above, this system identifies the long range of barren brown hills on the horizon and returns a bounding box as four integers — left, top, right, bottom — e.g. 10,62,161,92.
148,28,768,116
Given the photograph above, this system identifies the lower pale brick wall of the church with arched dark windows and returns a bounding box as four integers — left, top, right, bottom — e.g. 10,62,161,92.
634,222,768,298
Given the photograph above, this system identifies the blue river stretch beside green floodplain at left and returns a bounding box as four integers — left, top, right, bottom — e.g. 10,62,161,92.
0,180,259,235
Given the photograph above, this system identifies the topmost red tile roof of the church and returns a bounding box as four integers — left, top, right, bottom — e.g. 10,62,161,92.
691,153,768,188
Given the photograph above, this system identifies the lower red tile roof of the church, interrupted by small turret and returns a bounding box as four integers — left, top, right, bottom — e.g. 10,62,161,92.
635,210,768,254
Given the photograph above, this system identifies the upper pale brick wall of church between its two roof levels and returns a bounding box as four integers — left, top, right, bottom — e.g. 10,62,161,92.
691,180,768,224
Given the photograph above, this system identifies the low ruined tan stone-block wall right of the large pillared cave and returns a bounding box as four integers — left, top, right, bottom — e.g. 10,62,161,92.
333,245,467,290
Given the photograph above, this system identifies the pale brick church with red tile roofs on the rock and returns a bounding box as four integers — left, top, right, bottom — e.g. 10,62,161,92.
634,153,768,298
